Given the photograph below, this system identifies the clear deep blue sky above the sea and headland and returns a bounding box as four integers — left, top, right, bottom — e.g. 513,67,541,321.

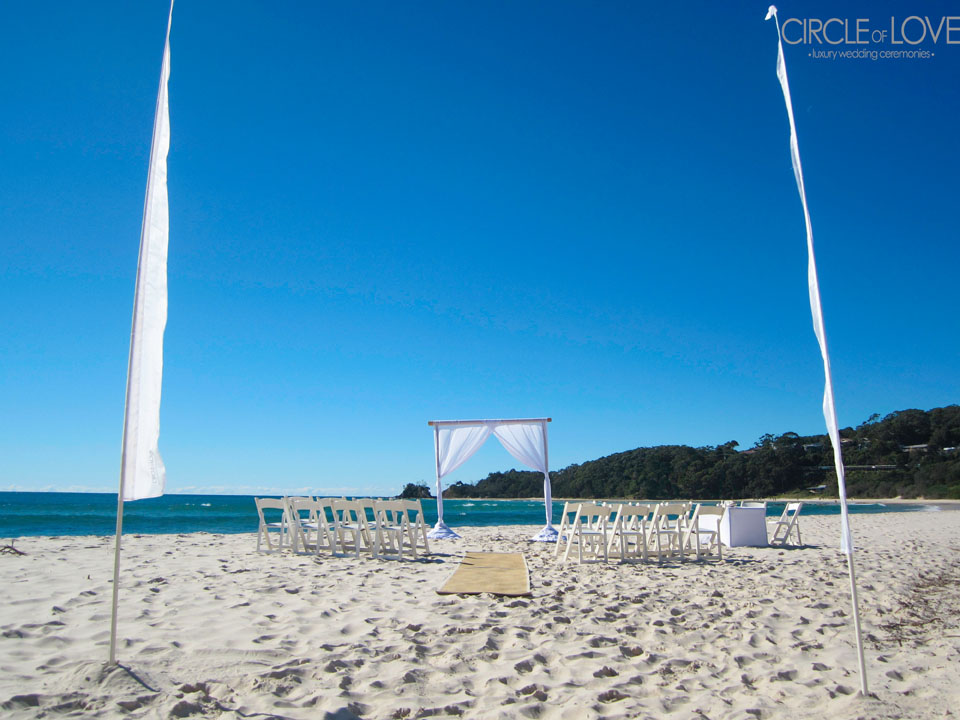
0,0,960,494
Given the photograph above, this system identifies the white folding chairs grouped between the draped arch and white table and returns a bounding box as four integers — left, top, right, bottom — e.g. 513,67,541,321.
554,502,723,563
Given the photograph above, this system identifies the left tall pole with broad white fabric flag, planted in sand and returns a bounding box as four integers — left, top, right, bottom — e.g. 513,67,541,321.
109,0,173,665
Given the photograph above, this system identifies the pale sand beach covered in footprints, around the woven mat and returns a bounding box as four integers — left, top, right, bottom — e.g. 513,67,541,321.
0,510,960,720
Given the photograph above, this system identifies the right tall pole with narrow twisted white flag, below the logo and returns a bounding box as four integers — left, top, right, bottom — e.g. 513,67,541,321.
765,5,868,695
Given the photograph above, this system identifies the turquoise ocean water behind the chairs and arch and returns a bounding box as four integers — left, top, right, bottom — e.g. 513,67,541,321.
0,492,936,539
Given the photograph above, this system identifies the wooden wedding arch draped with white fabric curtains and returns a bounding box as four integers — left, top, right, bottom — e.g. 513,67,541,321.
427,418,557,542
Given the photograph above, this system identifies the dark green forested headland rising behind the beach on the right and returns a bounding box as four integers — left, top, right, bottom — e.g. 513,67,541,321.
402,405,960,500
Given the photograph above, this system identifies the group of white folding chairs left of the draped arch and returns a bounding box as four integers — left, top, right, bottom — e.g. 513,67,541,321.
254,497,430,560
